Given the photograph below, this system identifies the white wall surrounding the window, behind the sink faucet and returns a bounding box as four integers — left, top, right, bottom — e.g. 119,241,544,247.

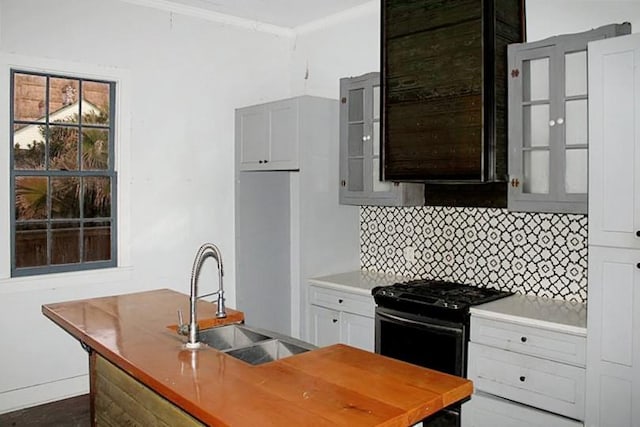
0,0,291,412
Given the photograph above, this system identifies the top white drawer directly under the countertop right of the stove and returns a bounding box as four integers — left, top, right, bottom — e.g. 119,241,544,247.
471,316,586,367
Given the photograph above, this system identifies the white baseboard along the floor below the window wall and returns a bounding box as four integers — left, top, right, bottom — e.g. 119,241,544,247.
0,375,89,414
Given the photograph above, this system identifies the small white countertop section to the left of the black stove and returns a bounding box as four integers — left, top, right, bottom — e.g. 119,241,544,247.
309,270,410,295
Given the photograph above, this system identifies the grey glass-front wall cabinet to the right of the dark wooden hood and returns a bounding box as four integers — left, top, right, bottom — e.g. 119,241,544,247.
508,24,631,214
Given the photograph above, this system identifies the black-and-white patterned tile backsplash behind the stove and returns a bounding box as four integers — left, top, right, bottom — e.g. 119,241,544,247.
360,206,587,302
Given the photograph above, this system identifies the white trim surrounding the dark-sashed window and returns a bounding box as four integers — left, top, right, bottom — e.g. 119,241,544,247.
0,54,131,293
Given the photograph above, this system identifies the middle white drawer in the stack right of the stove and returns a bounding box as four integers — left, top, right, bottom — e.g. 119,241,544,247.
468,342,585,420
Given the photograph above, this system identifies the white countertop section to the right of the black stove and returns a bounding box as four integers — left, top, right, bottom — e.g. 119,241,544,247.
471,294,587,336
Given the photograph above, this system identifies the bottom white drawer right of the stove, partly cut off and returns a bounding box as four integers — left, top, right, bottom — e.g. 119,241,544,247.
462,393,583,427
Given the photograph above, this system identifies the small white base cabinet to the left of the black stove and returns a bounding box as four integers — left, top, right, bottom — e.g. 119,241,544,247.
309,284,375,351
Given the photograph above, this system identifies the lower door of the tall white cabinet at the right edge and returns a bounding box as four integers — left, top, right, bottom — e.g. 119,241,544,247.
586,246,640,427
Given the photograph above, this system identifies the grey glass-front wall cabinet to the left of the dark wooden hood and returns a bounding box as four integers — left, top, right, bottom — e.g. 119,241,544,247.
340,72,424,206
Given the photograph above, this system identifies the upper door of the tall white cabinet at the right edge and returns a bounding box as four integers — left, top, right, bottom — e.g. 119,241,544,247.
589,34,640,249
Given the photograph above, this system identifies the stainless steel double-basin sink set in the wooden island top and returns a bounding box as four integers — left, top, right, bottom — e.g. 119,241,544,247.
199,324,316,365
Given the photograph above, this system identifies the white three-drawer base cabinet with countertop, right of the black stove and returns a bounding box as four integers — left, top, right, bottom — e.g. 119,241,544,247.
462,295,586,427
